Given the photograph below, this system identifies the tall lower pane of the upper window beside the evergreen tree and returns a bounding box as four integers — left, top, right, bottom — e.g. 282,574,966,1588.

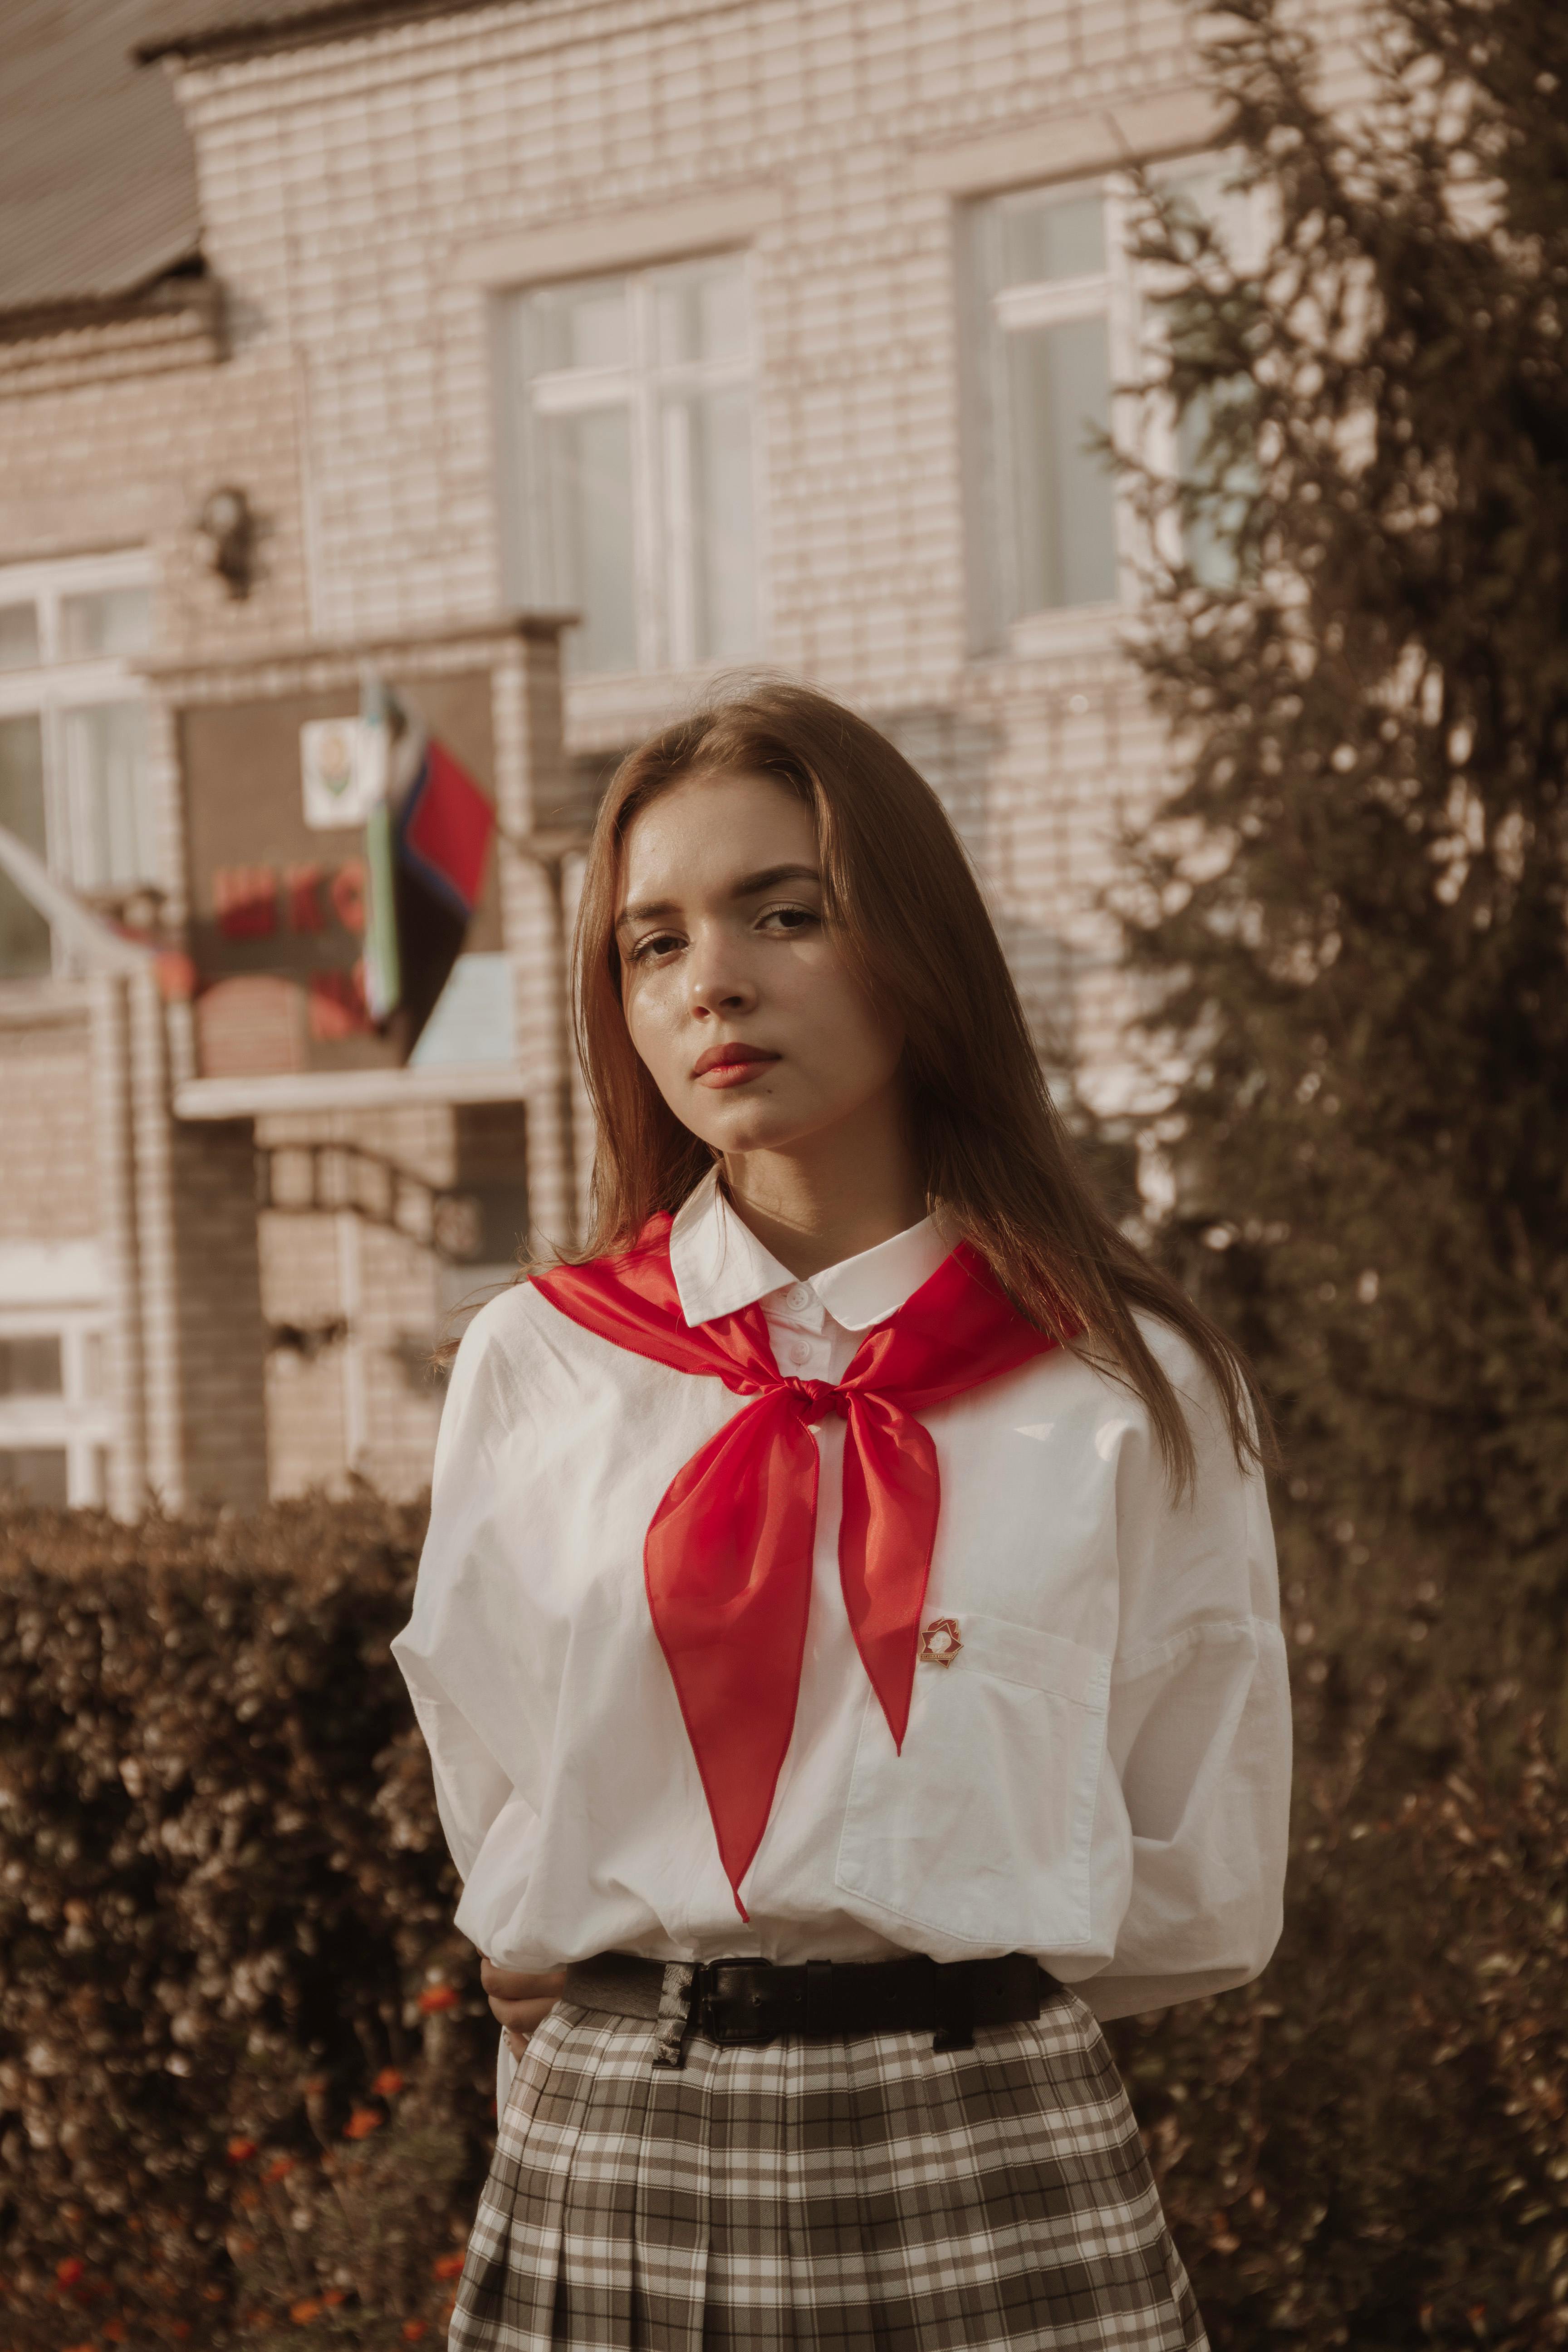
1006,318,1117,618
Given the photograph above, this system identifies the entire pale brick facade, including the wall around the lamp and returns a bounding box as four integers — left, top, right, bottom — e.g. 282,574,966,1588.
0,0,1382,1491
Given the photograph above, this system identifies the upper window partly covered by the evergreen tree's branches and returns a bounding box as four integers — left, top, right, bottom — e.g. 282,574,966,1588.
969,162,1260,647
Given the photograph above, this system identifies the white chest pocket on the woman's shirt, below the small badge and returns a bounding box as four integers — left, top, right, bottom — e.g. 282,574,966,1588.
837,1611,1110,1952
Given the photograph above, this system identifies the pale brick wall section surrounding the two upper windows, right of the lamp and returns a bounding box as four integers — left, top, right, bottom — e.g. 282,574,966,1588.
150,0,1363,1047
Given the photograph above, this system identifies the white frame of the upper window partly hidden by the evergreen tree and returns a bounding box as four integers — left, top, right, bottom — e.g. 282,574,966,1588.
964,148,1262,659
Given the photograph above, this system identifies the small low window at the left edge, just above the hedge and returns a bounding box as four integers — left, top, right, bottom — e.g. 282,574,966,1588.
0,1308,113,1508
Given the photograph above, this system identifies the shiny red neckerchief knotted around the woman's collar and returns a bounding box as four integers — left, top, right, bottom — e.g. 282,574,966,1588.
534,1216,1055,1919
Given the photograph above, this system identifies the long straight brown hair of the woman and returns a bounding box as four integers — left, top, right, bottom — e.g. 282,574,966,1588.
562,680,1262,1491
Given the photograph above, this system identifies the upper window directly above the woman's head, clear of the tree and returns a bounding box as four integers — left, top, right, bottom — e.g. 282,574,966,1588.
503,254,757,675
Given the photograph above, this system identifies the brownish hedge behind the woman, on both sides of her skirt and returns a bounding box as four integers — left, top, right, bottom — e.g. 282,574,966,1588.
0,1494,1568,2352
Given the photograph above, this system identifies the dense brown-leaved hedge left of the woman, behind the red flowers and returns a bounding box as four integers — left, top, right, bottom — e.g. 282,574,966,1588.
0,1496,496,2352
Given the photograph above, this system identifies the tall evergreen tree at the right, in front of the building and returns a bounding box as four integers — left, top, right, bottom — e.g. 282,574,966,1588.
1122,0,1568,1752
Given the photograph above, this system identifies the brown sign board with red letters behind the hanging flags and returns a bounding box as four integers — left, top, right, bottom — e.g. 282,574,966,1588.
179,670,501,1077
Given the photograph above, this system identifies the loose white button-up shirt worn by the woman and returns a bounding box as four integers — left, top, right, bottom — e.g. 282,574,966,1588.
392,1178,1291,2060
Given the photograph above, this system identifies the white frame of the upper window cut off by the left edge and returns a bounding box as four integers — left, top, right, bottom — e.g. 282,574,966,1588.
0,548,160,941
